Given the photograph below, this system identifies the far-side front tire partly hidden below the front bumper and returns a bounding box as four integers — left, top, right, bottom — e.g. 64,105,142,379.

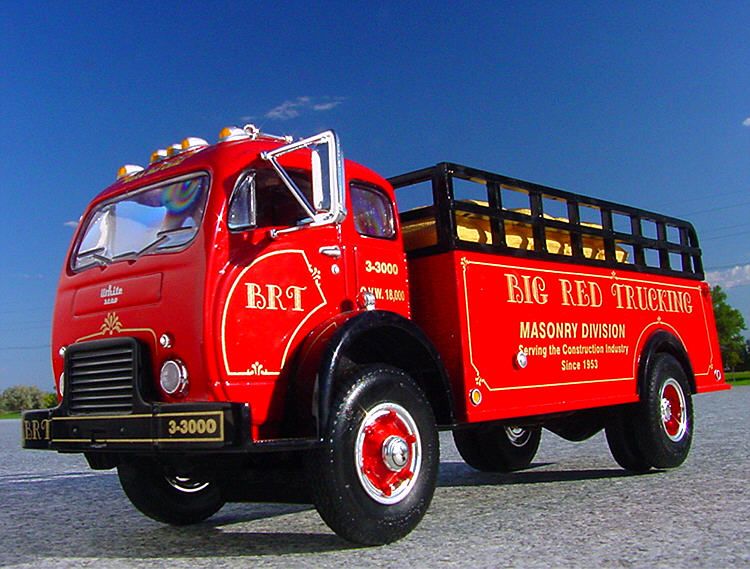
117,458,224,526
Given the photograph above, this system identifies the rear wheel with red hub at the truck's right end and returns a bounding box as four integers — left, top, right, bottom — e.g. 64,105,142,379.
633,353,693,468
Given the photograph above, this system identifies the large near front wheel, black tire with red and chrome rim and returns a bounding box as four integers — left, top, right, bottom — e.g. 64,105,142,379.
309,365,440,545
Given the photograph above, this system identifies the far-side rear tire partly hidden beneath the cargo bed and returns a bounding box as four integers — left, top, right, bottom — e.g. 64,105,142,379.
453,425,542,472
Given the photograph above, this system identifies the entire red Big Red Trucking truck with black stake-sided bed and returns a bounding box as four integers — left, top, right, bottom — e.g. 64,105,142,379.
22,125,728,544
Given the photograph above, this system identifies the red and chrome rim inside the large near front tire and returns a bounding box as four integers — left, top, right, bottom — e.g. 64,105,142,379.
355,402,422,504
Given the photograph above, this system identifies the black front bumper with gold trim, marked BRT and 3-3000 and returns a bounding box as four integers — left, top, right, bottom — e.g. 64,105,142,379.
21,403,252,453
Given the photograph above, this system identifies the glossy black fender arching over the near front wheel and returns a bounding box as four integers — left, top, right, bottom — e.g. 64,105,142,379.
289,310,454,438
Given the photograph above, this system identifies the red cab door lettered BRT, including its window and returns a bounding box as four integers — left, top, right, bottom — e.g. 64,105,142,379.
220,133,346,400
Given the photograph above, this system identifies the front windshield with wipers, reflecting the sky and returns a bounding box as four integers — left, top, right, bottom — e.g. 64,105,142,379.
73,174,209,270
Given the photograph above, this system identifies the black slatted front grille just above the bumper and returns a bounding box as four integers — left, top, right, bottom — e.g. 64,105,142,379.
65,340,137,414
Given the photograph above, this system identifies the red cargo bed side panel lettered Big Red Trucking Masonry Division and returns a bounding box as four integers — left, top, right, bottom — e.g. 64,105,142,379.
410,251,726,422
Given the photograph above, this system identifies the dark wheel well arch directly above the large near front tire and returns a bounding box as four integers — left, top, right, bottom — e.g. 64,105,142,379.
335,326,453,425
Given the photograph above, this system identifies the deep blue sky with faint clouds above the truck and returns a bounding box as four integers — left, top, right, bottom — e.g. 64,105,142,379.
0,2,750,389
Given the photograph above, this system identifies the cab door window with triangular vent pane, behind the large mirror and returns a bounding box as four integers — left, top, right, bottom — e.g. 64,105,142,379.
228,169,312,230
